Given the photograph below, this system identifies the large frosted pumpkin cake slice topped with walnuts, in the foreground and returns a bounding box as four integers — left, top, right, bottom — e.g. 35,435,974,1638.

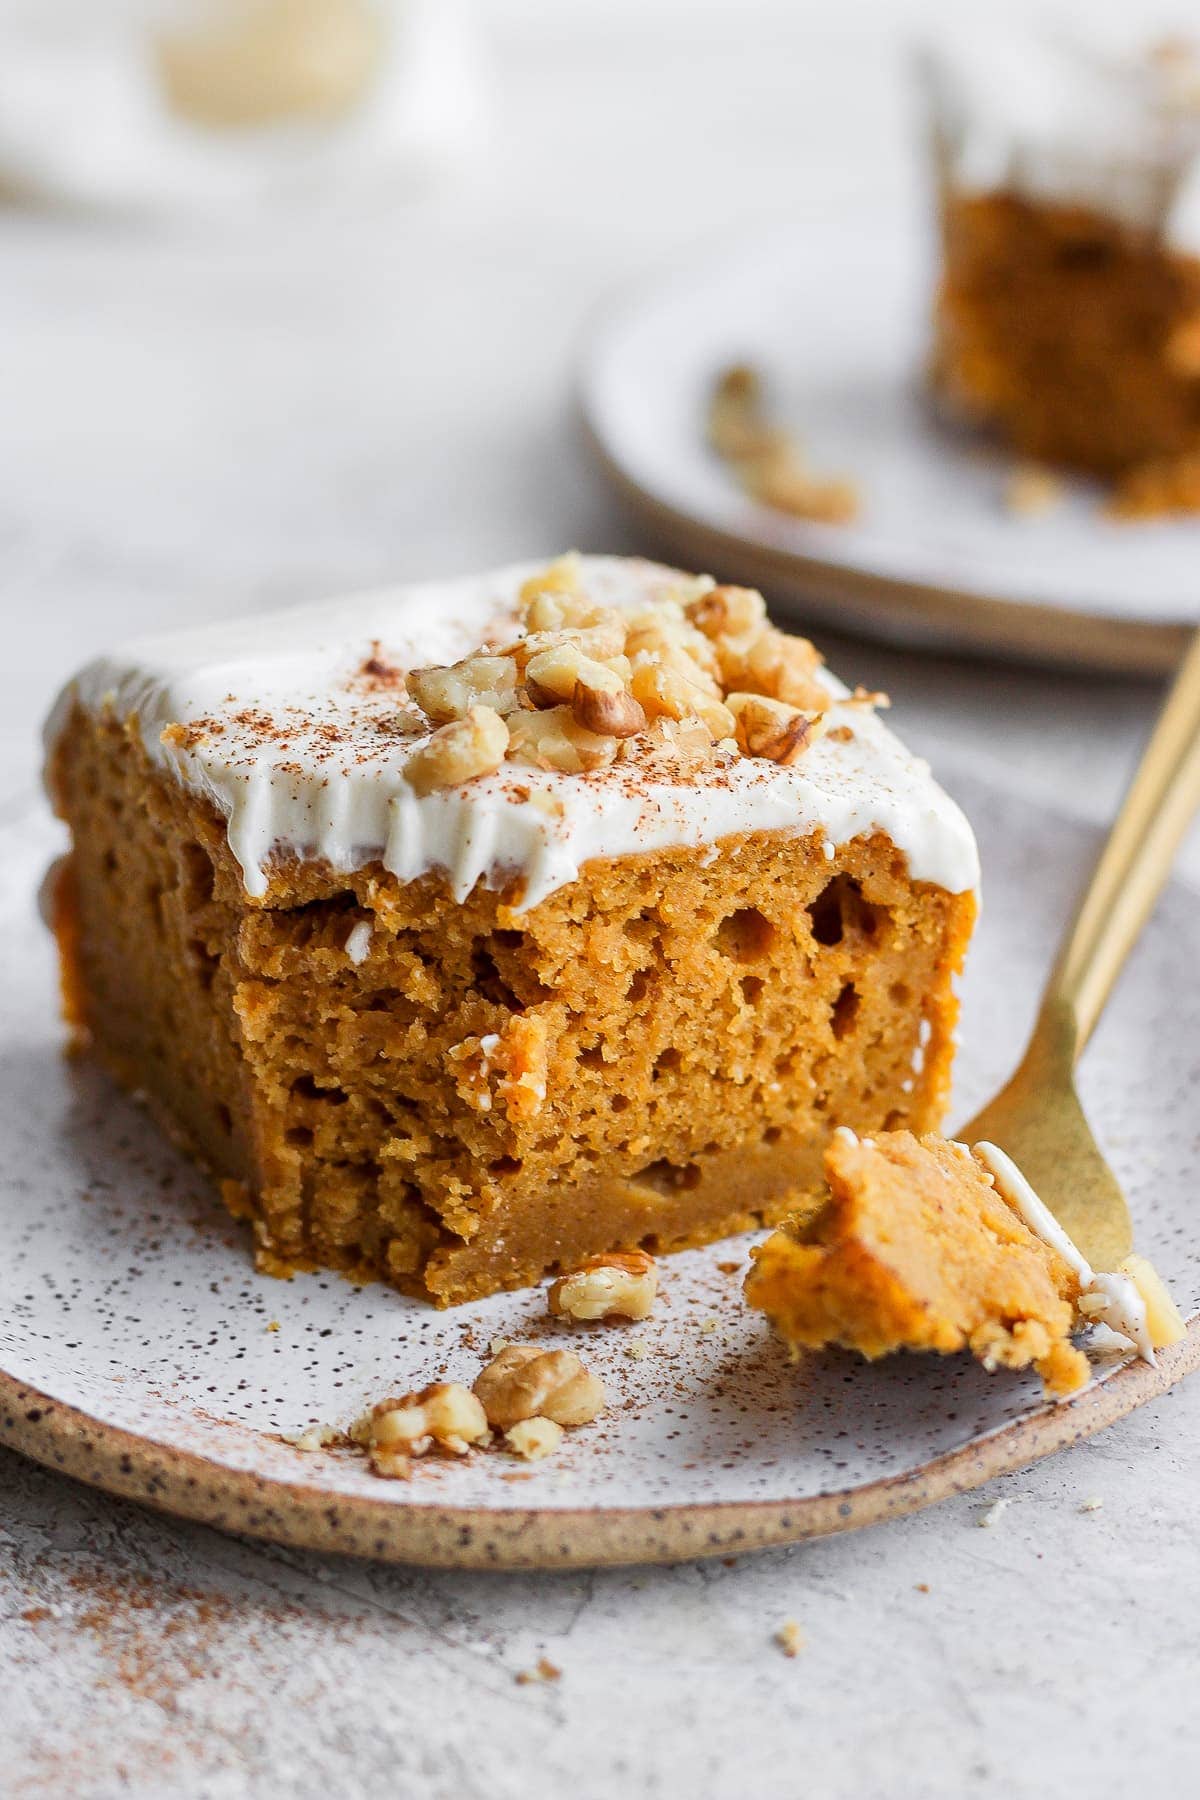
47,558,977,1303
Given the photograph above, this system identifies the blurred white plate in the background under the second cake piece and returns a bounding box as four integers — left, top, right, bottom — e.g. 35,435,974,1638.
579,218,1200,671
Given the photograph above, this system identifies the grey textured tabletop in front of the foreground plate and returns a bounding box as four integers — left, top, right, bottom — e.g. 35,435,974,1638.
0,1382,1200,1800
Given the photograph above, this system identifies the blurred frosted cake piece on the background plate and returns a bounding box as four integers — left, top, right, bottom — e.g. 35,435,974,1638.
925,31,1200,517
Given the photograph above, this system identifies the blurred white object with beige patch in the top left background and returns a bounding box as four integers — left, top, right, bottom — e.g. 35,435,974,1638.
0,0,482,211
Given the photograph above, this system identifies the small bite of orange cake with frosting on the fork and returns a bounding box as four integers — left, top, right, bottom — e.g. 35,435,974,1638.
747,1129,1184,1395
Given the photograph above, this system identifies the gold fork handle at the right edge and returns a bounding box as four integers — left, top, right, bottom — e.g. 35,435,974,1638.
1034,630,1200,1062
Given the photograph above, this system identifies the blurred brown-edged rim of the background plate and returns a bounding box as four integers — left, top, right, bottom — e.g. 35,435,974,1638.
570,239,1195,677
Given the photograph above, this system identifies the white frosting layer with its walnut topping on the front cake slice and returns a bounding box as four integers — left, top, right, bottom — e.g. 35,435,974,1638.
47,556,979,907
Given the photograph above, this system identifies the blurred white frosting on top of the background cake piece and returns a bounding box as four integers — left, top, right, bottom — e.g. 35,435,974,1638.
921,20,1200,254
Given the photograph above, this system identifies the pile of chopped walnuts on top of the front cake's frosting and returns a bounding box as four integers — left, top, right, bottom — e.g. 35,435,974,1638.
405,556,867,794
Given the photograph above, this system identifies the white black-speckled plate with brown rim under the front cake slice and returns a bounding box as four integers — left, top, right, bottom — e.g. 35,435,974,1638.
0,769,1200,1568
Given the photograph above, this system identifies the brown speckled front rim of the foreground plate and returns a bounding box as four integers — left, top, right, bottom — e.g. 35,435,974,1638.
0,1314,1200,1571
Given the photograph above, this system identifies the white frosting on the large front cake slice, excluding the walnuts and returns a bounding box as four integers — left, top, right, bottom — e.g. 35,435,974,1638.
47,556,979,905
